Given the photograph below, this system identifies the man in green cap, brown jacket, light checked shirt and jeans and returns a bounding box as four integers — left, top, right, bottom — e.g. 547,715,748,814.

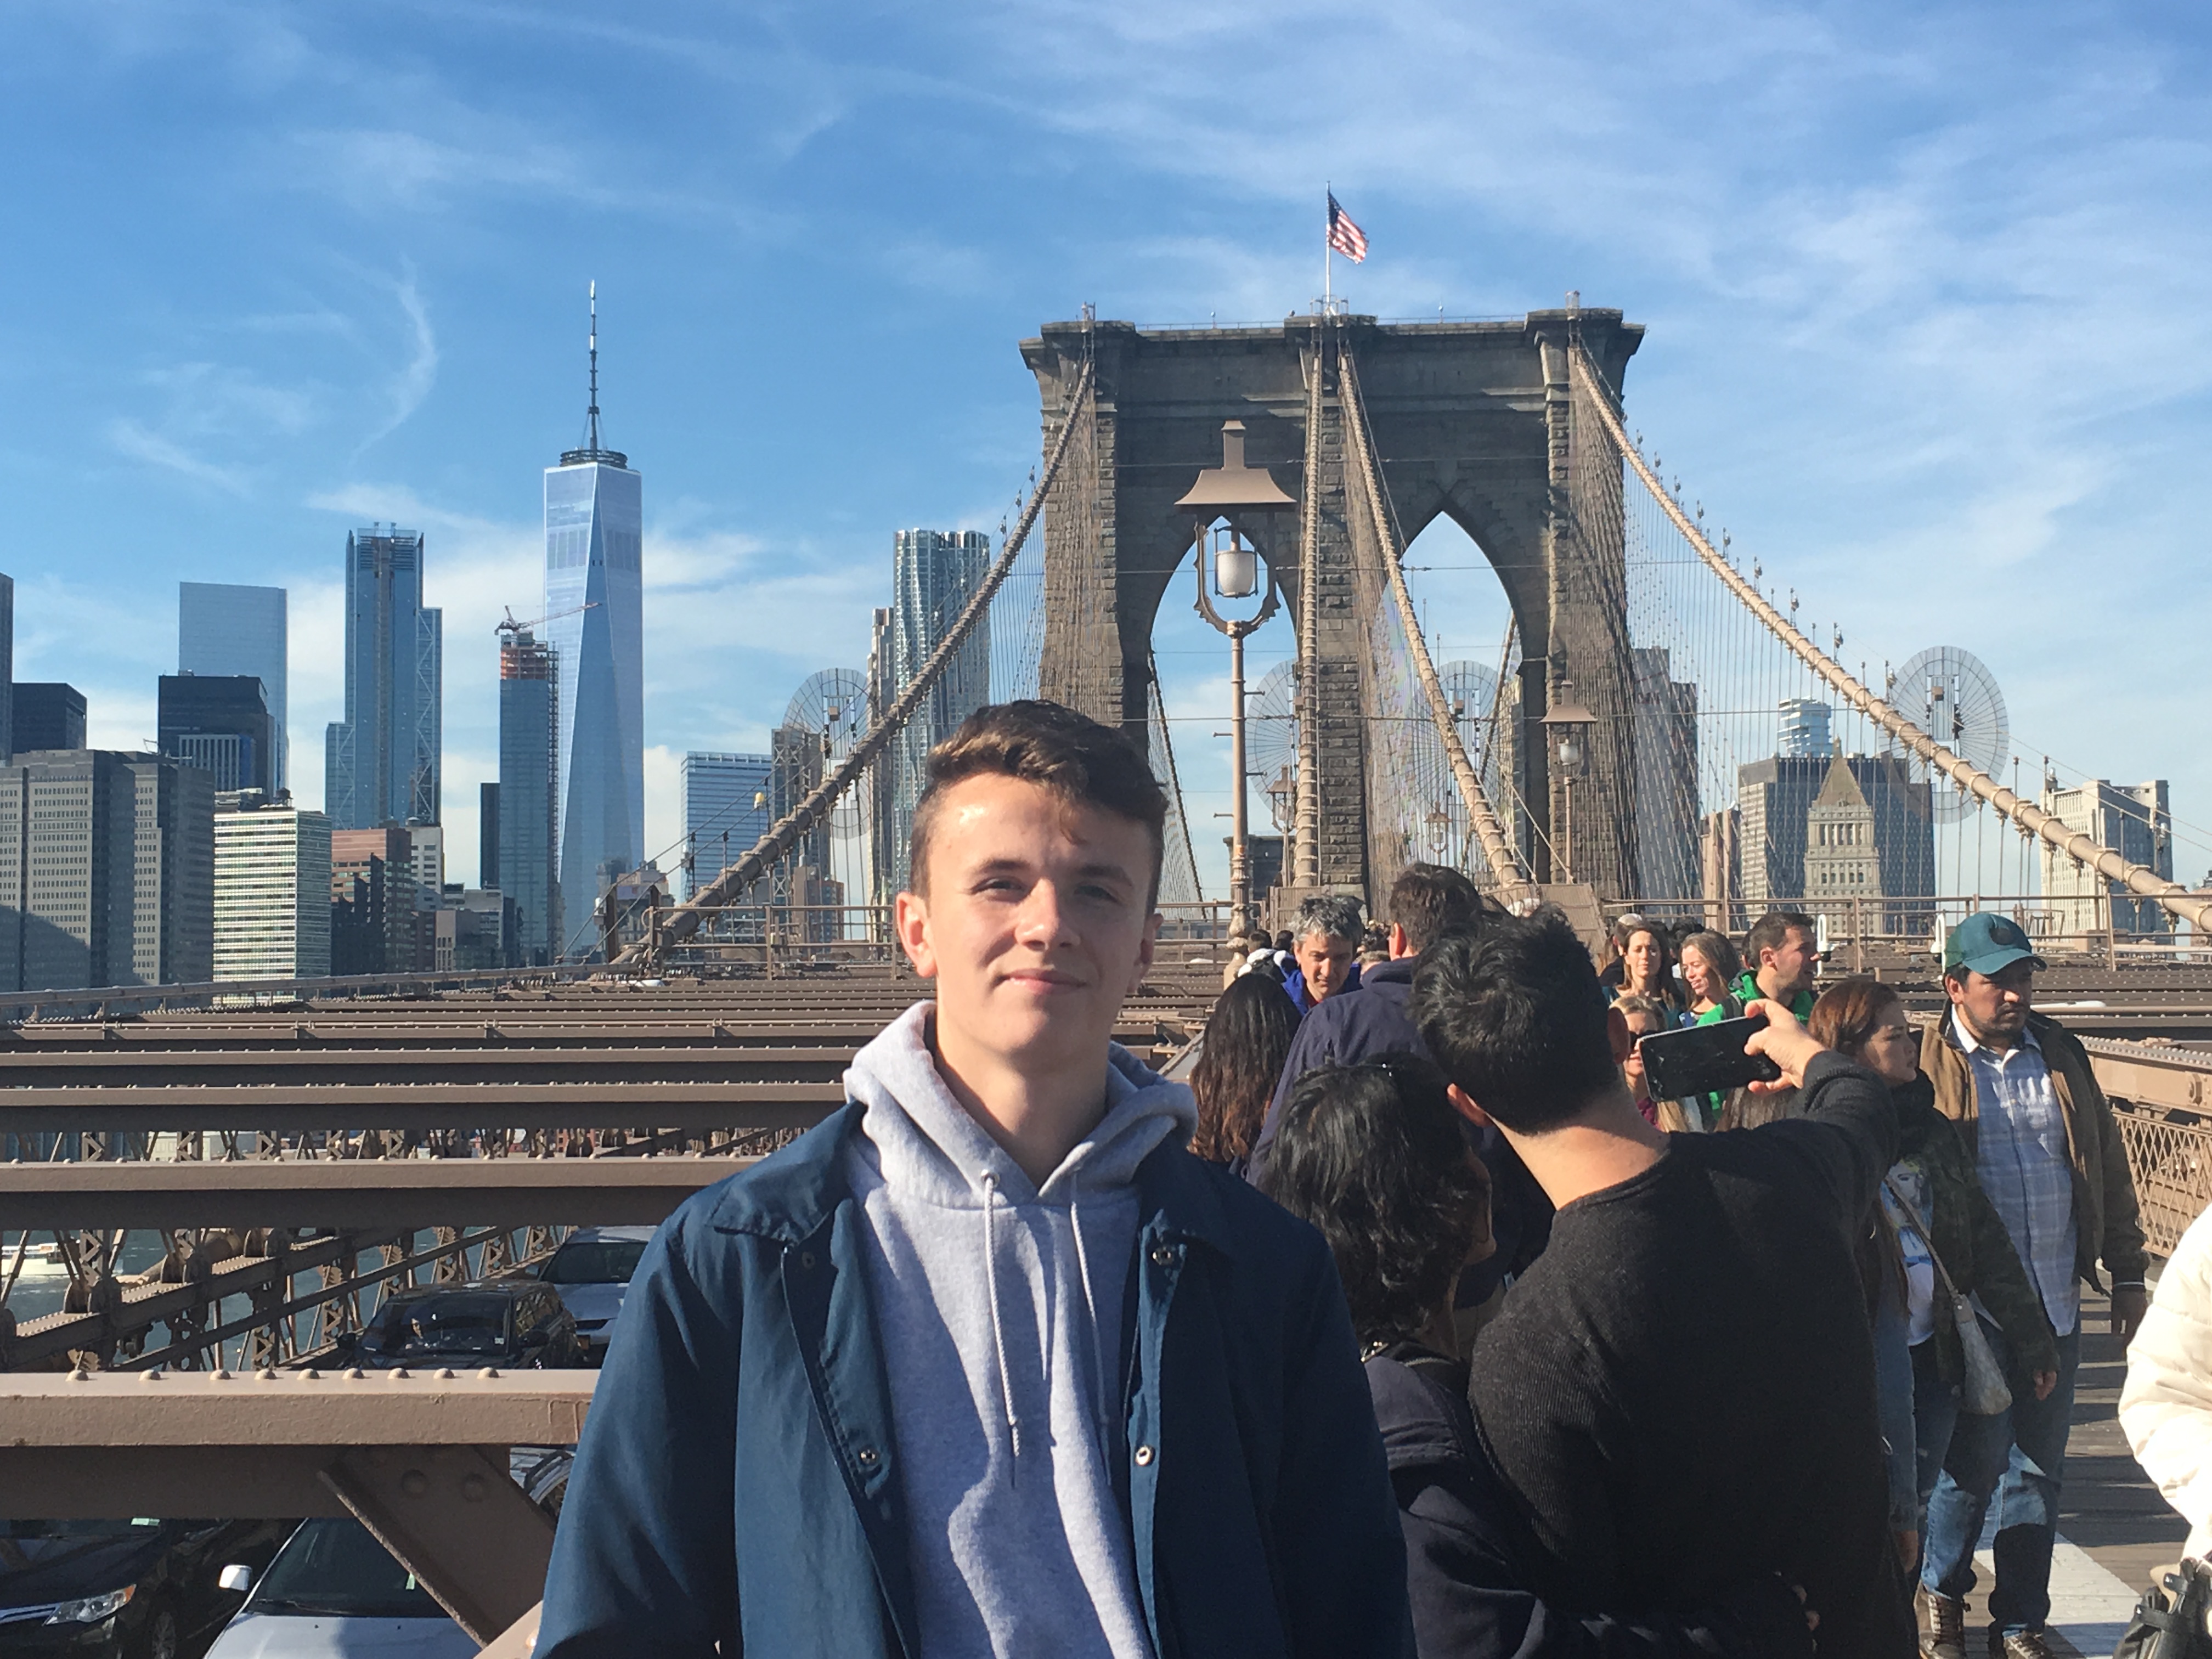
1920,911,2148,1659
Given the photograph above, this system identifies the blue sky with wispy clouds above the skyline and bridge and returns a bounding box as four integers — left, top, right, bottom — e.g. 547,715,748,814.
0,0,2212,898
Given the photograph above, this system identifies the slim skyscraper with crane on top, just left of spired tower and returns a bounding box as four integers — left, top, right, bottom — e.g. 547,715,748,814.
487,628,566,967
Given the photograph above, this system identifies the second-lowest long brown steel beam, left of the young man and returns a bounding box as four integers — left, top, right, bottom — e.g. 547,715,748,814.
0,1157,754,1232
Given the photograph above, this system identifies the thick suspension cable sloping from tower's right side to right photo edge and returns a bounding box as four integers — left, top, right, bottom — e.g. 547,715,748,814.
1573,349,2212,934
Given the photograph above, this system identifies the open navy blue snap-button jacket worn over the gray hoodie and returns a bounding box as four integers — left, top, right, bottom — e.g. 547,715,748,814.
535,1104,1411,1659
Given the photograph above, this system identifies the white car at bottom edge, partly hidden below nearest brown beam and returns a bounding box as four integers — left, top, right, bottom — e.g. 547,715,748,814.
208,1517,478,1659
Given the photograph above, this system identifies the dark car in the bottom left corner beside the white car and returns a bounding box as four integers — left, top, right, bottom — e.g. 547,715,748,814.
0,1520,292,1659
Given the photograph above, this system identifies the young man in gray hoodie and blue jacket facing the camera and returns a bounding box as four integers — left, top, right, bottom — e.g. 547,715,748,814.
538,703,1409,1659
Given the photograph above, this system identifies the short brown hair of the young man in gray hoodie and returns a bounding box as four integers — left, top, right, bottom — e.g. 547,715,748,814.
907,699,1168,907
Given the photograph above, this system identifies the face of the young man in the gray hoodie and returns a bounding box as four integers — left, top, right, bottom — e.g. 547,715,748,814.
898,774,1159,1075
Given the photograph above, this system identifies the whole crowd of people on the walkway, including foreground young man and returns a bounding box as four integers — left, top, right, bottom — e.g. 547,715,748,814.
538,701,2159,1659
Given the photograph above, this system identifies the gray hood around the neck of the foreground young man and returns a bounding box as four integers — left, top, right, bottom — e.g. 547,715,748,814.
845,1002,1199,1210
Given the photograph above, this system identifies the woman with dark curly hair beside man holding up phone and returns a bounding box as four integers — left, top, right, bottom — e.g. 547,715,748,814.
1267,1055,1812,1659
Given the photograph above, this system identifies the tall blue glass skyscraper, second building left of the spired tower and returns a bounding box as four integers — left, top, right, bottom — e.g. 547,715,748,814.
323,527,444,830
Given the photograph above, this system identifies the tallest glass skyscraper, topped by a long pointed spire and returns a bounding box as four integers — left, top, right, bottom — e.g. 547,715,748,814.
544,285,646,938
